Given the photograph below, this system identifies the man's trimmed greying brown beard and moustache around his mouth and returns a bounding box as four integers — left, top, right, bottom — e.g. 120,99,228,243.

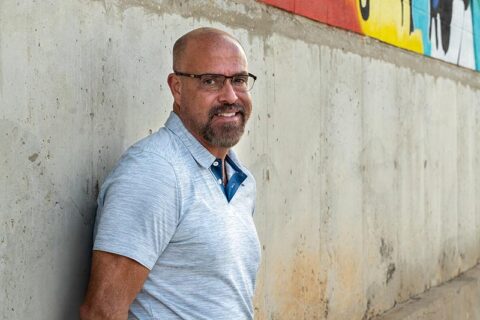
199,103,249,148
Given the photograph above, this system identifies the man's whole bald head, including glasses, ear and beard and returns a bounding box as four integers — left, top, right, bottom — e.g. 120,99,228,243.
168,28,256,155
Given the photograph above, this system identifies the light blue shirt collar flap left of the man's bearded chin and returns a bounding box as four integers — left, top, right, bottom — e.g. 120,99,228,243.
165,111,217,168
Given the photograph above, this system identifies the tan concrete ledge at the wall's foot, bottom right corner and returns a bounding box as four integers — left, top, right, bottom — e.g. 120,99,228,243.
374,266,480,320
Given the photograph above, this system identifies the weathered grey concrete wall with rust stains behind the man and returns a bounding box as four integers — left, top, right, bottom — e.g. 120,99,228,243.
0,0,480,319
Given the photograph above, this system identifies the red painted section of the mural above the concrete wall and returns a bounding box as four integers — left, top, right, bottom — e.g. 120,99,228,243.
259,0,362,33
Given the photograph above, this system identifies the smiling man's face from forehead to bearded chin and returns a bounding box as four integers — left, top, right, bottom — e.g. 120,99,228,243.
175,39,252,149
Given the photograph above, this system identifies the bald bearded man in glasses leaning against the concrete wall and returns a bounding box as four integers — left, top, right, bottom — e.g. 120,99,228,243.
80,28,260,320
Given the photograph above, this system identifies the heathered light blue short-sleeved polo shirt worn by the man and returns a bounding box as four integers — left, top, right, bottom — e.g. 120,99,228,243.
93,112,260,320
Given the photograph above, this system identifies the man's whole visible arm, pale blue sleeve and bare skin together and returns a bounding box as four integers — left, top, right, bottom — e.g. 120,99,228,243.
81,152,178,319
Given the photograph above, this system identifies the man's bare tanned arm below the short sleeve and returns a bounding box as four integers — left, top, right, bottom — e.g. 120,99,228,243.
80,251,149,320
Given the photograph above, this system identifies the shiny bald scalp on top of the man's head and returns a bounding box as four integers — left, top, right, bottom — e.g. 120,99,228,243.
173,28,244,71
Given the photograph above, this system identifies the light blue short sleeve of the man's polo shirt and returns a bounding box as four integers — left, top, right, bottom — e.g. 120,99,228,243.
93,151,178,270
